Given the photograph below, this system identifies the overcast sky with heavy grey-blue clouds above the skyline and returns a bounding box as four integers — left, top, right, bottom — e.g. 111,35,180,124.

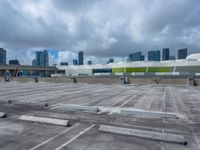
0,0,200,64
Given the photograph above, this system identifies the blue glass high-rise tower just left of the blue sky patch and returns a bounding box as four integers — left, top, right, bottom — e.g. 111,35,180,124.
36,50,49,67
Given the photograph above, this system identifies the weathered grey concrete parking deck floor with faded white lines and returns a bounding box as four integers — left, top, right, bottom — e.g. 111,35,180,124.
0,82,200,150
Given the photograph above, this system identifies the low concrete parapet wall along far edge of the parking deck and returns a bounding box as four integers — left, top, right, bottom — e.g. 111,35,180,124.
0,76,194,86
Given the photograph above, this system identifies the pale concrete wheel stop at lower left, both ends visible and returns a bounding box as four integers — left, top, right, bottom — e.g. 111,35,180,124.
19,115,70,126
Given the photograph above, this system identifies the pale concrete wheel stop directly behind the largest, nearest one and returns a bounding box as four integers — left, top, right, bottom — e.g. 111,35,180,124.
121,110,180,119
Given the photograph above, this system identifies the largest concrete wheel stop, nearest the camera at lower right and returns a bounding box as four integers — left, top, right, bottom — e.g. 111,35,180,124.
99,125,187,145
